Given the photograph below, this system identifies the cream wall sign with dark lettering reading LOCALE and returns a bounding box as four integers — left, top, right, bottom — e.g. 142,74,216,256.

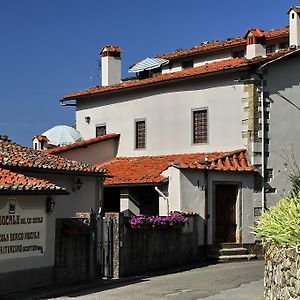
0,198,46,260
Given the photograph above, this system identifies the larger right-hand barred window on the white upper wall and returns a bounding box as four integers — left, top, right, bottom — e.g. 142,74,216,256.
193,109,207,144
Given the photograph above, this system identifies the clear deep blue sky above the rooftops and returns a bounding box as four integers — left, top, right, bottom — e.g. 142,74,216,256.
0,0,300,145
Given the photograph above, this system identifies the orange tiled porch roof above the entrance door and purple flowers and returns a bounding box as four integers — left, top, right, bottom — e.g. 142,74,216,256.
97,150,254,185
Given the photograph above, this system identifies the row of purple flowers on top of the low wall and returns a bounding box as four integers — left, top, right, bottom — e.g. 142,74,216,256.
129,213,187,228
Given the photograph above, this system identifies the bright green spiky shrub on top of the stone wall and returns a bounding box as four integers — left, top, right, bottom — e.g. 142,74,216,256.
254,191,300,248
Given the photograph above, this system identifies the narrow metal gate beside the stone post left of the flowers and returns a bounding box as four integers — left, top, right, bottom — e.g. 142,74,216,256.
101,217,114,278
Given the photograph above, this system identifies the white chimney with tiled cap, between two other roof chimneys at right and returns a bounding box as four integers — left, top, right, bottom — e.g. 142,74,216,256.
244,28,267,59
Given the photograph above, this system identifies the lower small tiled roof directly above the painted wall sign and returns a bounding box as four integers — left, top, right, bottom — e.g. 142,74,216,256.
0,168,67,194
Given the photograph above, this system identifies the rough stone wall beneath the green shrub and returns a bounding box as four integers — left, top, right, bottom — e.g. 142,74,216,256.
264,249,300,300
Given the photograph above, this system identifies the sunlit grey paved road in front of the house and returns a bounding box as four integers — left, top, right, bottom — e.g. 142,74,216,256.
45,261,263,300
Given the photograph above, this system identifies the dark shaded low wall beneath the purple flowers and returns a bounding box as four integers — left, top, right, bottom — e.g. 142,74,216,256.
120,216,203,276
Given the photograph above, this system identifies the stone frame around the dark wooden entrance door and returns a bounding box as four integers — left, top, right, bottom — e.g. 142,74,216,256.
212,181,243,244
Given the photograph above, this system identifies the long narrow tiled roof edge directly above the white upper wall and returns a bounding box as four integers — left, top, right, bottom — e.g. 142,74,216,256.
63,50,290,100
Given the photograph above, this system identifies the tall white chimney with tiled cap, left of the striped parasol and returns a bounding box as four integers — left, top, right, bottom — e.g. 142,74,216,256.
100,45,122,86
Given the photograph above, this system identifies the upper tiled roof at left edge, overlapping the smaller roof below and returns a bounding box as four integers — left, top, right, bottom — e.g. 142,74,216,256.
0,141,105,175
